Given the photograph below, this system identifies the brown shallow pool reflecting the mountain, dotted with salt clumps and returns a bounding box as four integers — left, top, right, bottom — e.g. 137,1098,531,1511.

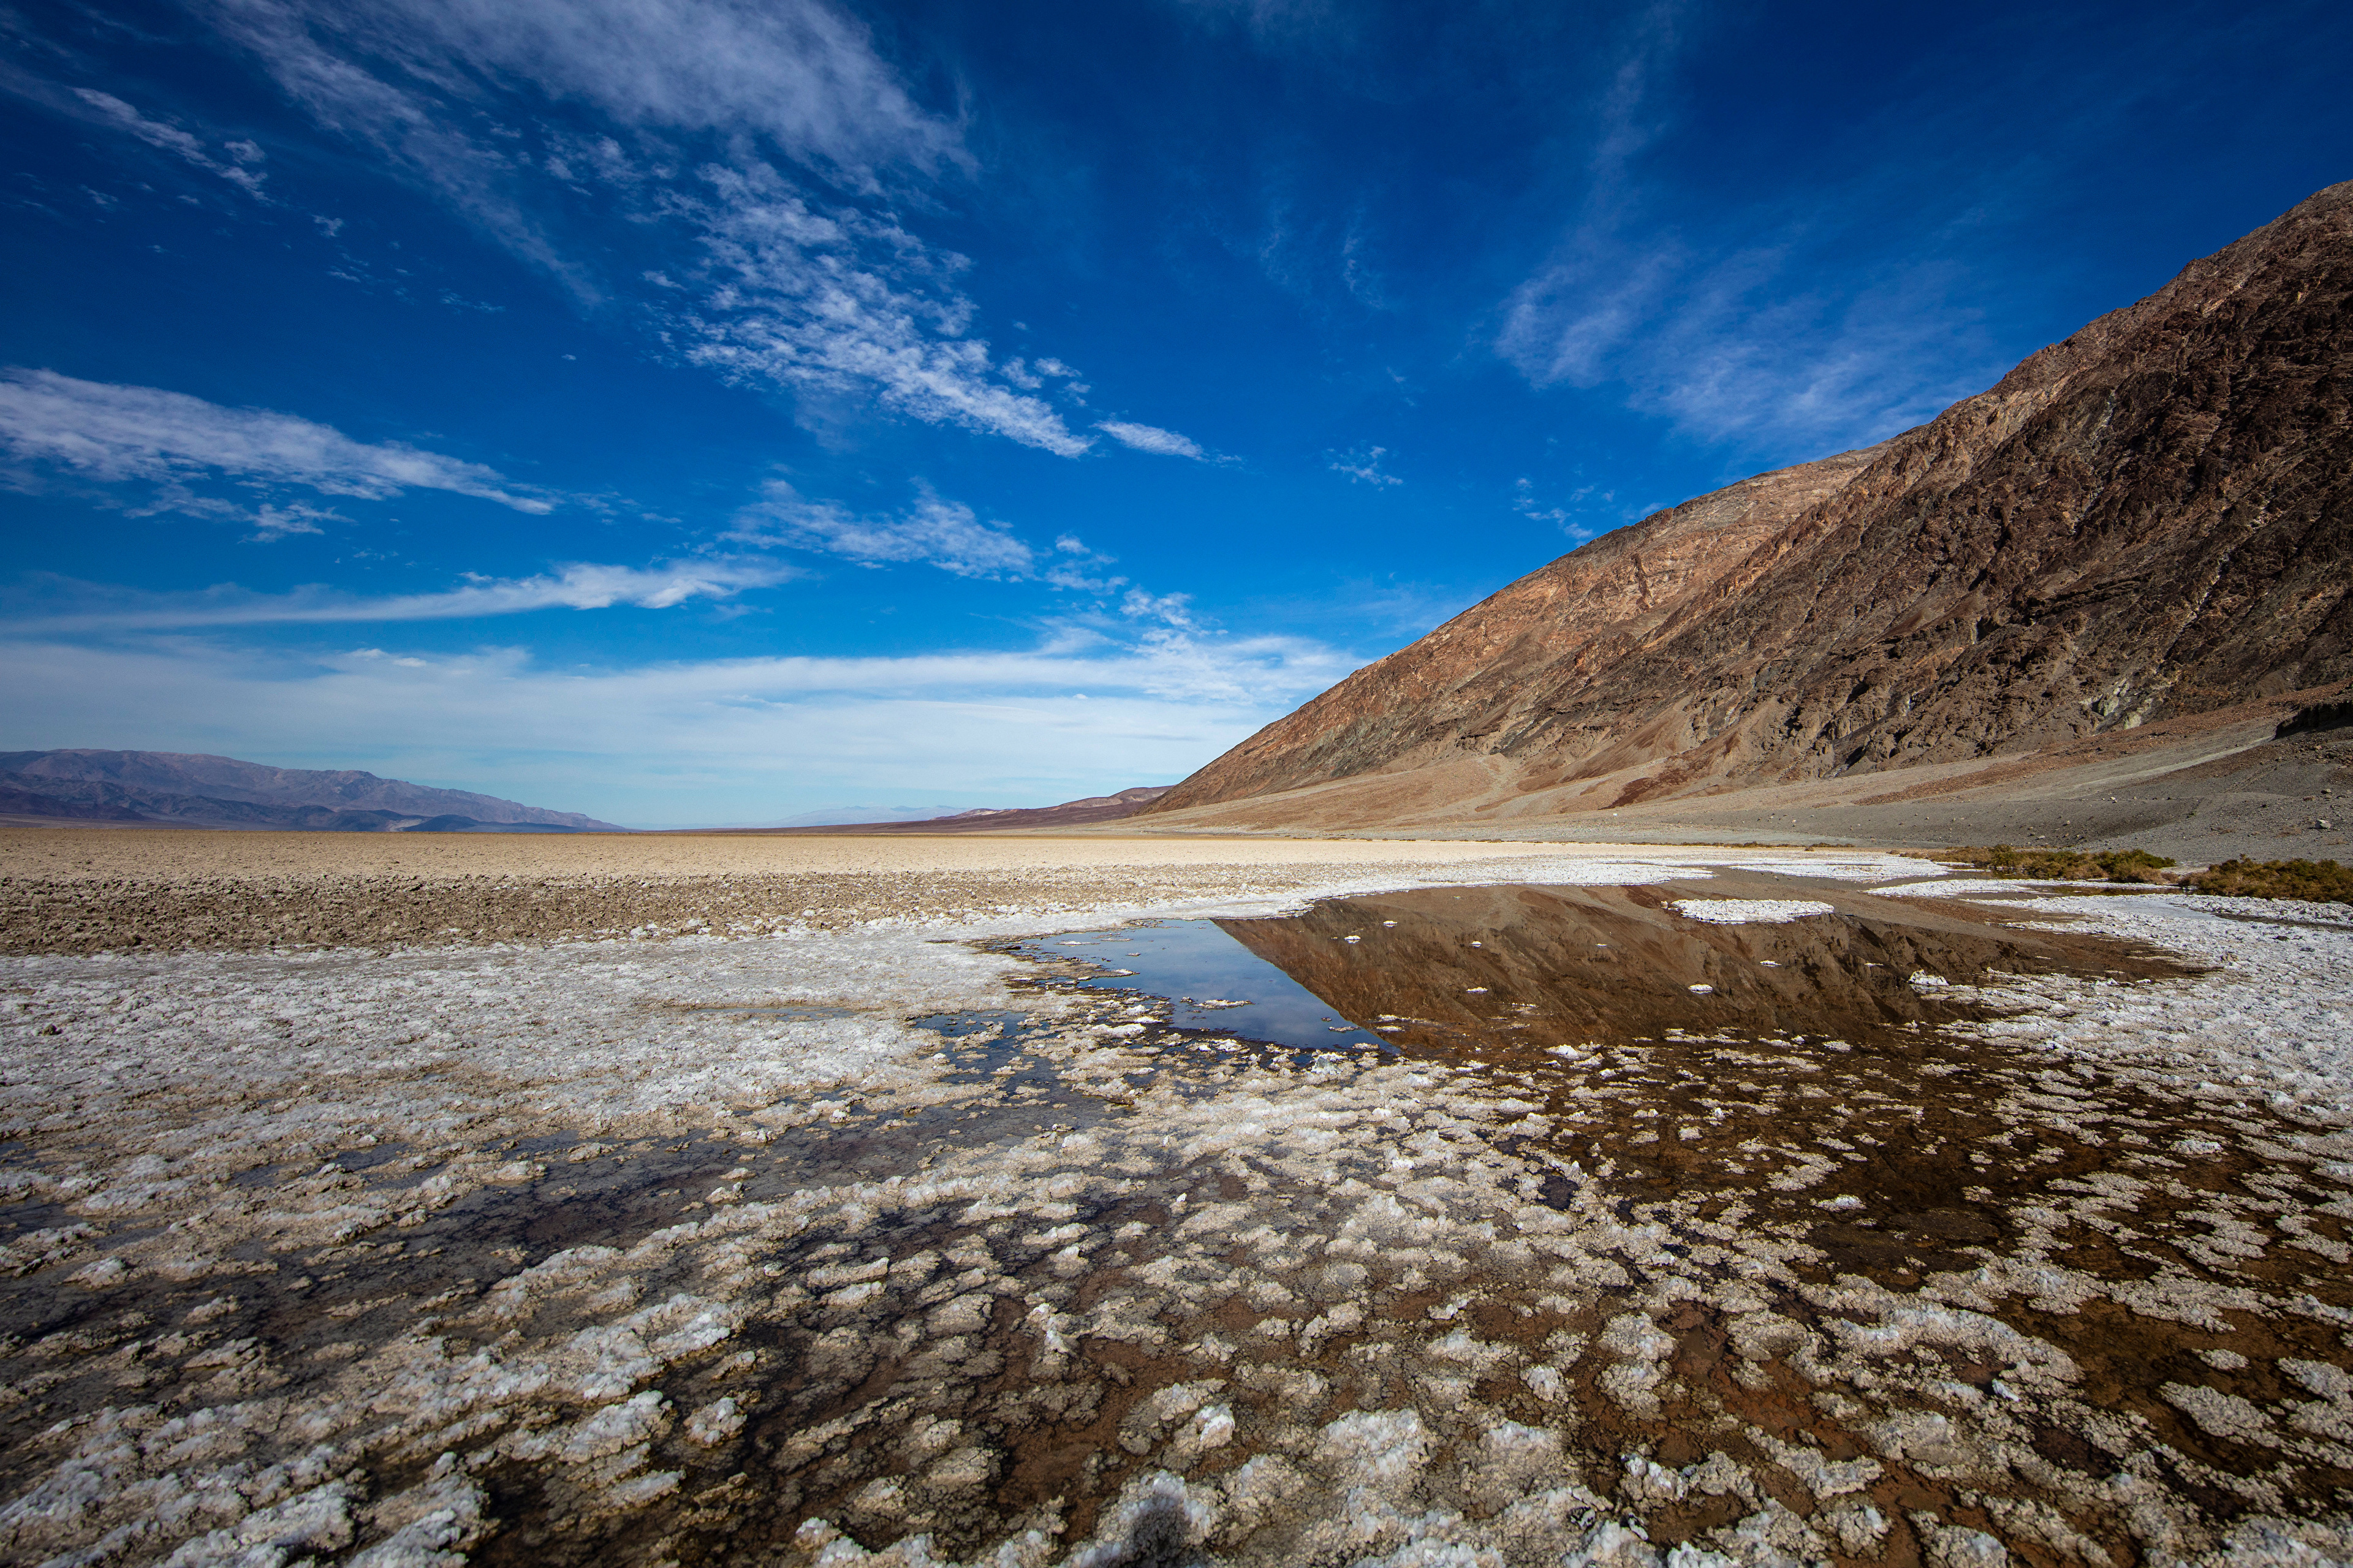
1219,874,2221,1286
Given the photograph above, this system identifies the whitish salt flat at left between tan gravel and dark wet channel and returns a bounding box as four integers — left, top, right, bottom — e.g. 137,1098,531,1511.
0,933,1019,1149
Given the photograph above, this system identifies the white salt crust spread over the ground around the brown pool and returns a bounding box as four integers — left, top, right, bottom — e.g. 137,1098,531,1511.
0,857,2353,1568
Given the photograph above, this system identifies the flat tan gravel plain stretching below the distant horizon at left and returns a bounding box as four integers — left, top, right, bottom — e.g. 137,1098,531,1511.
0,829,1581,953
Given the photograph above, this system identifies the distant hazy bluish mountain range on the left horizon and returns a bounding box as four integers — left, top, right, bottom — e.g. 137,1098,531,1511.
0,751,626,833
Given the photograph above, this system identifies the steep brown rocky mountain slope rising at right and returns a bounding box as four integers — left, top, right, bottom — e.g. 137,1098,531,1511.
1146,181,2353,812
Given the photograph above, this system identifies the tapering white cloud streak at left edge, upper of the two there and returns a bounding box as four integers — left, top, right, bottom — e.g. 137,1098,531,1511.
0,367,555,513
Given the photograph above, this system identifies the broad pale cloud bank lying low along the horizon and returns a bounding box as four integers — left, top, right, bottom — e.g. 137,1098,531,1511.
0,624,1355,824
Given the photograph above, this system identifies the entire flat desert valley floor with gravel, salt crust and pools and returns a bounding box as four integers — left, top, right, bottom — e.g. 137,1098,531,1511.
0,829,2353,1568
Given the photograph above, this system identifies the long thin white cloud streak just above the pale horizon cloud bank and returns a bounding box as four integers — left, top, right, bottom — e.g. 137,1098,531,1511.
9,560,800,635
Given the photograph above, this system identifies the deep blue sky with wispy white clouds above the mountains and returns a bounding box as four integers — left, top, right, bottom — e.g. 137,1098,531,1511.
0,0,2353,827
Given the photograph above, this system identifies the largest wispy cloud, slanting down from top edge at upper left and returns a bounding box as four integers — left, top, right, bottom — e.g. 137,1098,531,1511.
216,0,1092,456
